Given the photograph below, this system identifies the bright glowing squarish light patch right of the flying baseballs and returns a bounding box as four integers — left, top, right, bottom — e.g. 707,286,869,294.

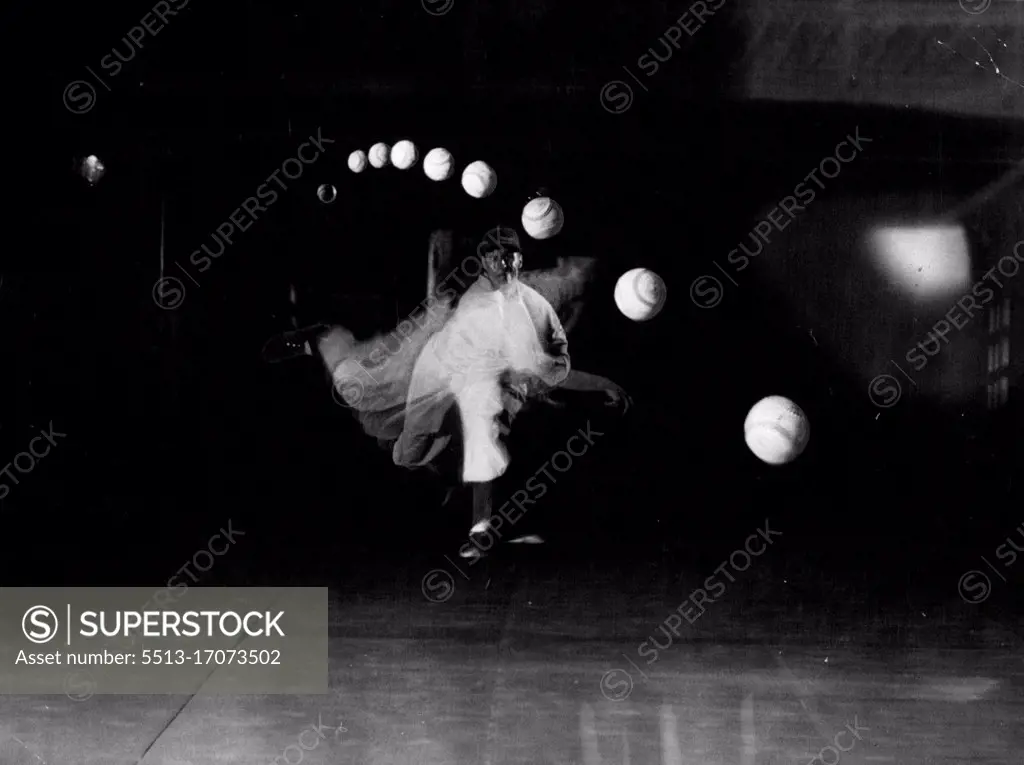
868,224,971,299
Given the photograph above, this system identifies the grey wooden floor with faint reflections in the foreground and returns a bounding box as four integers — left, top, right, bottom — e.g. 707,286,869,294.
0,572,1024,765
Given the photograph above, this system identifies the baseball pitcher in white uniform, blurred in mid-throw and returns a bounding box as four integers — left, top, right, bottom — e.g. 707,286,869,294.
258,228,630,557
